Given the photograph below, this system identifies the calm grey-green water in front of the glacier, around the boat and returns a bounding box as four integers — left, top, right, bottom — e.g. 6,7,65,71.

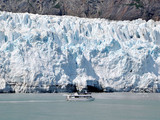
0,93,160,120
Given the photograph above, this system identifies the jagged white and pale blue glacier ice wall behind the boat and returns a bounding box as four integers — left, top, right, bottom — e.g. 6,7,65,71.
0,12,160,92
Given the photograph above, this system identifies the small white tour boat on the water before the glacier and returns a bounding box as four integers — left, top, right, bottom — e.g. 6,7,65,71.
66,93,95,101
